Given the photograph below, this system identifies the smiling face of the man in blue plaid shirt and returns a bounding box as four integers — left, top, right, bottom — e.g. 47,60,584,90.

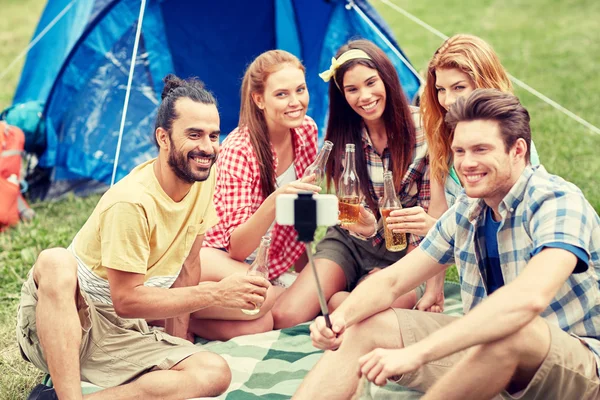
452,120,527,210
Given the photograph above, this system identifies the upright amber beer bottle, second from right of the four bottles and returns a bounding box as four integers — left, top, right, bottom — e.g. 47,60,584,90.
337,143,360,225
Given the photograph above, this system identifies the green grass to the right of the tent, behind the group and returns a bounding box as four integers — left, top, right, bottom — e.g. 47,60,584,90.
373,0,600,211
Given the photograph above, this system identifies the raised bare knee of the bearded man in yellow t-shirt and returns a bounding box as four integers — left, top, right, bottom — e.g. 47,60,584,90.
33,248,77,293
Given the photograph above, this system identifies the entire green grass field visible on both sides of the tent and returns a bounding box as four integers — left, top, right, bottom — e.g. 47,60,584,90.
0,0,600,400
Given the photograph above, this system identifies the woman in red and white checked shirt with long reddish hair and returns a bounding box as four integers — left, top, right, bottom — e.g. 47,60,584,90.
199,50,321,336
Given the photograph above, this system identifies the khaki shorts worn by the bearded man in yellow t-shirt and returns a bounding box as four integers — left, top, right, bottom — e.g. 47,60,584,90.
17,271,204,388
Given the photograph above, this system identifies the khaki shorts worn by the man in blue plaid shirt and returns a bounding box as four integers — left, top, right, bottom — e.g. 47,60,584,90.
394,309,600,400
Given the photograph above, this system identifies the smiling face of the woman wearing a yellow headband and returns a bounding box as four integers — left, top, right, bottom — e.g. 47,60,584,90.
342,64,386,121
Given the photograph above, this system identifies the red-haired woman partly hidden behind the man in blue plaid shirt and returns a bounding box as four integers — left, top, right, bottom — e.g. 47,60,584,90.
418,34,539,216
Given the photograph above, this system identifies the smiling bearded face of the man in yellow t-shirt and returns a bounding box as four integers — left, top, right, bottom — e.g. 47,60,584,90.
160,97,220,184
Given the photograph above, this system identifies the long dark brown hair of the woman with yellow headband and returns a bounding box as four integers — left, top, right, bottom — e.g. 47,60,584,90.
326,40,416,214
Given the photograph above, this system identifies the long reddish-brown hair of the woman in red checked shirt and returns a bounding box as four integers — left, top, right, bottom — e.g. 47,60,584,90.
238,50,305,198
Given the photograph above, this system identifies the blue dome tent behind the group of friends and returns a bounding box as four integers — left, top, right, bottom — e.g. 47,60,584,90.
14,0,419,198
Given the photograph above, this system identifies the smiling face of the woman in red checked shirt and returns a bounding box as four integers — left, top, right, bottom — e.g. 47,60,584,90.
252,64,309,134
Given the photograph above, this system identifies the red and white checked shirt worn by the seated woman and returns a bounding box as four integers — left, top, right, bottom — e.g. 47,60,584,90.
203,116,317,279
